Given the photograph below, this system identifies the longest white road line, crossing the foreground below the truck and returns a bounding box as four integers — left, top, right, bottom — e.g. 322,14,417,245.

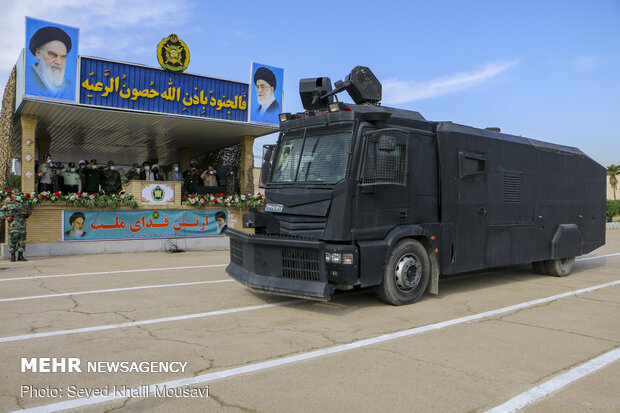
13,280,620,412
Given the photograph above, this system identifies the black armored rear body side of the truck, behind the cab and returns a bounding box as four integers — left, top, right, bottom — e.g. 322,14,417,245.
437,123,605,273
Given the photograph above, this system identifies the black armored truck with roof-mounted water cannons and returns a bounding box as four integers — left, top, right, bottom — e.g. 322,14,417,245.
226,66,605,305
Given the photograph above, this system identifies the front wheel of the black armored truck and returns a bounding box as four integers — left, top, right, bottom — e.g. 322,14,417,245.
376,239,431,305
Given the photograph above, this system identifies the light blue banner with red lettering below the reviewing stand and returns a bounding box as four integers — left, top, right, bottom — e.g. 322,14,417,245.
62,209,228,241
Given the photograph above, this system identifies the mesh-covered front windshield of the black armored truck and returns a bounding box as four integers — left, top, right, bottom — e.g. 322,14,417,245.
271,124,352,183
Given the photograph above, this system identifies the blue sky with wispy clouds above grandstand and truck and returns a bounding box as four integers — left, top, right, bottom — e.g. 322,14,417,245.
0,0,620,166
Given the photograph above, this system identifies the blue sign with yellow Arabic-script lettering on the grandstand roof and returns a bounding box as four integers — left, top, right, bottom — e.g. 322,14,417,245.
79,57,249,122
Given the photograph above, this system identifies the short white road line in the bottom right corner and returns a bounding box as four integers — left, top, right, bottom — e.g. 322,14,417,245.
487,348,620,413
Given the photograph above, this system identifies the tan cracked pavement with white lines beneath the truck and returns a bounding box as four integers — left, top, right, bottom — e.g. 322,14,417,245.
0,230,620,412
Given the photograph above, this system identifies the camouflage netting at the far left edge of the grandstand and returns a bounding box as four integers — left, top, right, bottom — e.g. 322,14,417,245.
0,67,15,190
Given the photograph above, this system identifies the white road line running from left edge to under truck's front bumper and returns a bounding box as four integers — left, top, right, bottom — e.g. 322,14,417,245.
0,299,305,343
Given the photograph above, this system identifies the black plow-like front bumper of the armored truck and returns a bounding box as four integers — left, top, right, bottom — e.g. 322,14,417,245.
226,229,334,301
